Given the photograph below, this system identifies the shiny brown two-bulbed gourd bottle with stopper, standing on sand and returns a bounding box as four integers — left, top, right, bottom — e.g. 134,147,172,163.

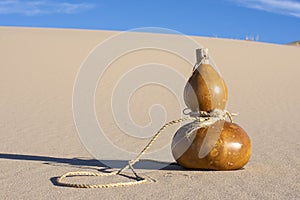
172,49,251,170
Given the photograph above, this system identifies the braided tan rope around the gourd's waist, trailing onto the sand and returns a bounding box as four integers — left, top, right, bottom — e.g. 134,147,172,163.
57,109,236,188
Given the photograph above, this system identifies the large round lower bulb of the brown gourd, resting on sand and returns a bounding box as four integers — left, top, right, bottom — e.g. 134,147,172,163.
172,121,251,170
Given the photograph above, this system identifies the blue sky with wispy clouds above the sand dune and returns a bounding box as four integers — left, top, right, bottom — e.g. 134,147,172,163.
0,0,300,44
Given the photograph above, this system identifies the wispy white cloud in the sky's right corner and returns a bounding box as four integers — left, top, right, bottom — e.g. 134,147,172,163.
230,0,300,18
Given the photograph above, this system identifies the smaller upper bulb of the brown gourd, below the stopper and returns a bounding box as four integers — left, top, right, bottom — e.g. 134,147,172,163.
184,64,228,111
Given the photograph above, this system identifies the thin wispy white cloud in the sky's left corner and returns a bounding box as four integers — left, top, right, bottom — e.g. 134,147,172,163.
0,0,93,15
